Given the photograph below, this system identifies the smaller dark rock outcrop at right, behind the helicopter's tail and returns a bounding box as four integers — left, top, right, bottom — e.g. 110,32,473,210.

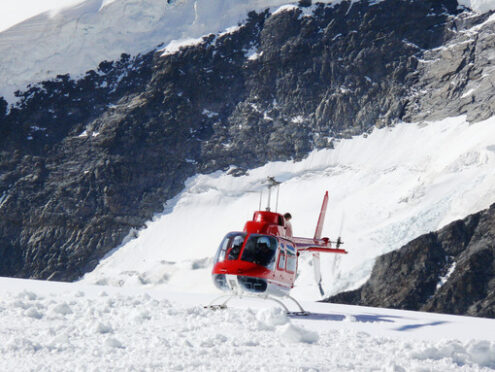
327,204,495,318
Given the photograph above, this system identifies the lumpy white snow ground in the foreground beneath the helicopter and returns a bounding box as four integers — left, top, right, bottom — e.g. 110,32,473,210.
0,278,495,372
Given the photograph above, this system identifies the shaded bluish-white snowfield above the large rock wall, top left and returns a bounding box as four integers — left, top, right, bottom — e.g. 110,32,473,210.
0,0,341,102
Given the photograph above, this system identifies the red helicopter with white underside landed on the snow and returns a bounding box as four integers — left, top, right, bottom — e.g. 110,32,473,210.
209,177,347,315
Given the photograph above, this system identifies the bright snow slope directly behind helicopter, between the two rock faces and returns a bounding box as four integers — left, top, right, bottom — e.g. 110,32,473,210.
83,117,495,299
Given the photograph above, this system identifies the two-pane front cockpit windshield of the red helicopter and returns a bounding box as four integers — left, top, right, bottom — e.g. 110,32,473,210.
215,232,277,270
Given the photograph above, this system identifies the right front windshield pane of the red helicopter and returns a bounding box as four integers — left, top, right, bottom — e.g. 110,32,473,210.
241,234,277,270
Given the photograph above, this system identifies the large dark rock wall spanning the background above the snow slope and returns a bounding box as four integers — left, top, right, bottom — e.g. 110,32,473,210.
0,0,489,280
